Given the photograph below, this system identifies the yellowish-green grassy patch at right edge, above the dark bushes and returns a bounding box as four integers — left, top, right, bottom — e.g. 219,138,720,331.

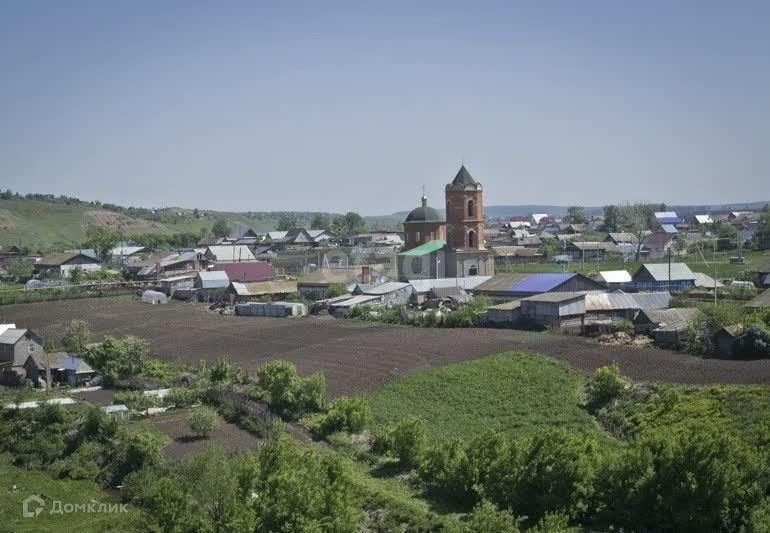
608,385,770,448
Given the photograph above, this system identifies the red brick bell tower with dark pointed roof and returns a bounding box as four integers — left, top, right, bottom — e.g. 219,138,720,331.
446,165,485,251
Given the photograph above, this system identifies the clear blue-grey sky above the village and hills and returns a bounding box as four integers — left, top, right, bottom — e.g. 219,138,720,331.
0,0,770,215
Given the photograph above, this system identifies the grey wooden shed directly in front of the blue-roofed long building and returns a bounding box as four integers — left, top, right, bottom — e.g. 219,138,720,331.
520,292,586,332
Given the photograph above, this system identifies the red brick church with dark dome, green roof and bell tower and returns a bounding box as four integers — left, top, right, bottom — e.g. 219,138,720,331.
398,165,495,281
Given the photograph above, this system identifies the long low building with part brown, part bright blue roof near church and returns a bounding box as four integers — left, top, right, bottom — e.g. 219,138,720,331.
472,272,606,303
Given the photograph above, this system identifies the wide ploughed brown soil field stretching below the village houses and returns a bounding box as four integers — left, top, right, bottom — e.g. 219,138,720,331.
6,297,770,396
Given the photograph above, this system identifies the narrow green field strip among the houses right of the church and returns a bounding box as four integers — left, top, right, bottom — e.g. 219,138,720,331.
496,250,770,279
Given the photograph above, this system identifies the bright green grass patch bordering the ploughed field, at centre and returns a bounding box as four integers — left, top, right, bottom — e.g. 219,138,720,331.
369,352,597,439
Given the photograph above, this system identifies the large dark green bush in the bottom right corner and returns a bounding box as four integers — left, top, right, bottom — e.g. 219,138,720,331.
604,426,767,531
